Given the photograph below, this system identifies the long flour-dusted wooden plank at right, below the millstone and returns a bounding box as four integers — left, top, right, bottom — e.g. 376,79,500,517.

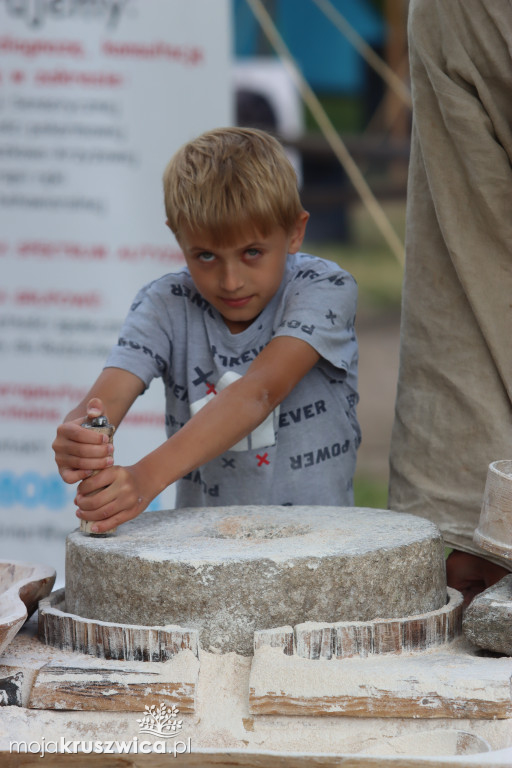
249,647,512,719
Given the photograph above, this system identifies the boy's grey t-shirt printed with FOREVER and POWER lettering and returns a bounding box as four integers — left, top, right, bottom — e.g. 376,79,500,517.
106,253,360,507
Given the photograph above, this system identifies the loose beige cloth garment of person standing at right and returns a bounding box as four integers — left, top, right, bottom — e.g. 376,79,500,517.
389,0,512,569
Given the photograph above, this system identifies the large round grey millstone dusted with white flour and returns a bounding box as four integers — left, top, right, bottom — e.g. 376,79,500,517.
66,506,446,655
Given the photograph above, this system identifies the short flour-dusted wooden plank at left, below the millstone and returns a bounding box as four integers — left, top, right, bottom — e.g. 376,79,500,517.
28,651,199,712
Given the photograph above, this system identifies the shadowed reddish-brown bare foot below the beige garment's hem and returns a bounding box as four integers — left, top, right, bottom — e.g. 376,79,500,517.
446,549,510,606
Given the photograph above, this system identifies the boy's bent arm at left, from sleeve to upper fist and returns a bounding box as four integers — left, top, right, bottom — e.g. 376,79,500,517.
52,368,144,483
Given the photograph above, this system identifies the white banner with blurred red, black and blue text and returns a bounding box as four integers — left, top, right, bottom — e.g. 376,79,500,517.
0,0,232,582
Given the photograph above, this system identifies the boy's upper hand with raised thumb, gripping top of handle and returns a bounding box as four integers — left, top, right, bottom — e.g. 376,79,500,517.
52,397,114,483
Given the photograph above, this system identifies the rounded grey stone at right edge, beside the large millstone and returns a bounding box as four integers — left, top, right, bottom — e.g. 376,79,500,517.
462,573,512,656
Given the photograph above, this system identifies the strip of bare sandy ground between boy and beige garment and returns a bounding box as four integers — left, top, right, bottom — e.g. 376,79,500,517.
356,315,400,482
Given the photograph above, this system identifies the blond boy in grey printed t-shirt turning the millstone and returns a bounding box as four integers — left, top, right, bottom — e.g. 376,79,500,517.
53,128,360,533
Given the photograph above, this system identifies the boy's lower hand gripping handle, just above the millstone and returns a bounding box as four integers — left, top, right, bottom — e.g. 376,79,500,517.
75,466,148,533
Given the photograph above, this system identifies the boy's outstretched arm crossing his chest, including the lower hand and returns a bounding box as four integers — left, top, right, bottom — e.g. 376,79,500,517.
76,336,320,533
